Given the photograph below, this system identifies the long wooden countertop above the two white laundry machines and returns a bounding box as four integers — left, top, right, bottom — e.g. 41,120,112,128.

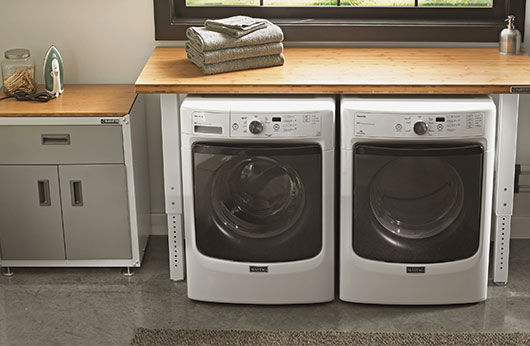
136,47,530,94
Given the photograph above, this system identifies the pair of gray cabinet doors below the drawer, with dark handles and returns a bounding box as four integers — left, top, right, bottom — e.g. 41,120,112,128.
0,165,132,260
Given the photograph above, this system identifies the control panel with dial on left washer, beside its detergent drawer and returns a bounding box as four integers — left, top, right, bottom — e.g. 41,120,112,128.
230,113,322,137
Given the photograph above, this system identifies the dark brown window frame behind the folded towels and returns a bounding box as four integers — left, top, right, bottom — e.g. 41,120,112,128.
153,0,526,42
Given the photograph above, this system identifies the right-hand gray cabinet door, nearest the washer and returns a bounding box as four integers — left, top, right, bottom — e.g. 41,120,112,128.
59,165,132,260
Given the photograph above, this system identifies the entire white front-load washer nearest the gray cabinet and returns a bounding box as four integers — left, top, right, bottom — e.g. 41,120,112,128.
181,96,335,304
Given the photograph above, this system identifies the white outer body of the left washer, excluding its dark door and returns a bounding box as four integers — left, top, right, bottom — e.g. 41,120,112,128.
181,96,335,304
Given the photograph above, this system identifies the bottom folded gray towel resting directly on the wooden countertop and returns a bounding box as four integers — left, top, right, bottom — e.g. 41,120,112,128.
188,54,284,74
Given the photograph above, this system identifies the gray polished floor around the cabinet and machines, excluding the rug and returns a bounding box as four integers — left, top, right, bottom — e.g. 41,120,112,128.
0,236,530,345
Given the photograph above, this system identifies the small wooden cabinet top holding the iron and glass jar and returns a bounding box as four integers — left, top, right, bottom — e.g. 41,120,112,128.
0,84,136,117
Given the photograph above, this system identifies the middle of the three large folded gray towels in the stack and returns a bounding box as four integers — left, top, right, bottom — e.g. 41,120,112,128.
186,42,283,64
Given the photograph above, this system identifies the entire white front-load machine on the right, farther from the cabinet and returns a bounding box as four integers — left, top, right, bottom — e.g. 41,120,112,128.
340,96,496,304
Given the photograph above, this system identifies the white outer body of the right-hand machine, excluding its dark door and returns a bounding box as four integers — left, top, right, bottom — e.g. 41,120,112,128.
340,96,496,305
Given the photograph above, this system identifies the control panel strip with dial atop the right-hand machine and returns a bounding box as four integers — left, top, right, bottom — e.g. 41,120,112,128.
354,113,484,138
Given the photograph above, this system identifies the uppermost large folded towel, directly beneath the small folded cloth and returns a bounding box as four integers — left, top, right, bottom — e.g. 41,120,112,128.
186,22,283,52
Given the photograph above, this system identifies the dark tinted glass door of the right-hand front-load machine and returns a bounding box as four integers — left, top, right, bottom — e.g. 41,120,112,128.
352,144,483,263
